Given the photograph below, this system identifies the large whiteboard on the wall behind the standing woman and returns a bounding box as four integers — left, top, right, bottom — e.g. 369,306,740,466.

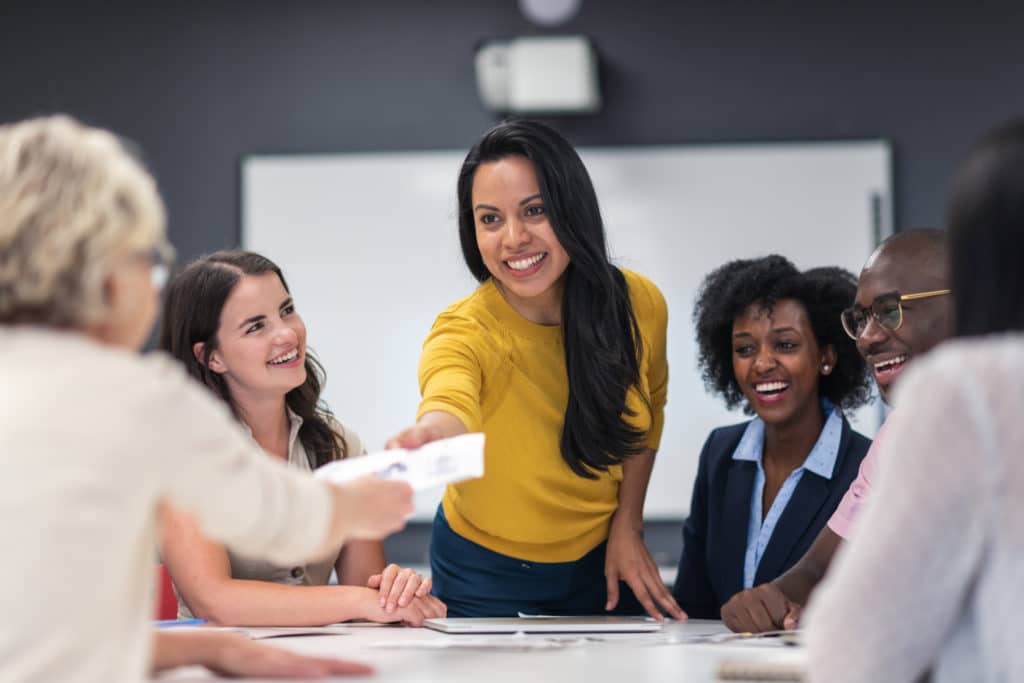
242,140,892,519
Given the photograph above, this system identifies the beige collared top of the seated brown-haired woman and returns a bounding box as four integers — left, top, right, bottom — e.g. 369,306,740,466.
177,409,366,618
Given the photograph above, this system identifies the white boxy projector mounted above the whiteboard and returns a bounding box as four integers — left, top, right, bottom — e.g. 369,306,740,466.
476,36,601,114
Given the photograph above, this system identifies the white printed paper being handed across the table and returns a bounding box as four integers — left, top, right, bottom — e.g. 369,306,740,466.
313,433,483,490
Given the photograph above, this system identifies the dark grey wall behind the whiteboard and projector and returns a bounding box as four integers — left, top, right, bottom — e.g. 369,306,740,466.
0,0,1024,256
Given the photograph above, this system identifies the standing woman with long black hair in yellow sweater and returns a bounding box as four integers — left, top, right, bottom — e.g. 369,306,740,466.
389,121,685,618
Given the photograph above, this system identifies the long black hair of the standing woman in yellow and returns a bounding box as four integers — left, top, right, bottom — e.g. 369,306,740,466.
458,120,650,478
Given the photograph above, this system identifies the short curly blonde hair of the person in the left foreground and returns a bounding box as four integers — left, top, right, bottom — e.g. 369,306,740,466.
0,116,166,328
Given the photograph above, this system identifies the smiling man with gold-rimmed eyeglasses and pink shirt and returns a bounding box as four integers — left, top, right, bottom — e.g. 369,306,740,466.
722,228,952,633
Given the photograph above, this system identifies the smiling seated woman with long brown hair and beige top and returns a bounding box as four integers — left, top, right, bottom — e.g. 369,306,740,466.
160,251,444,626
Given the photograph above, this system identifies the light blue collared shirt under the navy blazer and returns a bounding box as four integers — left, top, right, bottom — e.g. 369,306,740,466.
732,400,843,588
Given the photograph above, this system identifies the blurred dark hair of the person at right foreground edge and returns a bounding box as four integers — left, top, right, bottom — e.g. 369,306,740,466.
948,118,1024,337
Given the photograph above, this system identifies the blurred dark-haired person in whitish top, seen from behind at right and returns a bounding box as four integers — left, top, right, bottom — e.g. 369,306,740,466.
805,118,1024,683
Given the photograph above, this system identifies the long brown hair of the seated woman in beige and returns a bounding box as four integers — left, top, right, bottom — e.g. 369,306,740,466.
159,250,347,468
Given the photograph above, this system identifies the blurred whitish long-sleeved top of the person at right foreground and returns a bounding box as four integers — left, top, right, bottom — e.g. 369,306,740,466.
806,334,1024,683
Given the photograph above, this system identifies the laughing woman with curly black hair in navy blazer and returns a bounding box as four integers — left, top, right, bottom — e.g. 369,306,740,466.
673,256,870,618
